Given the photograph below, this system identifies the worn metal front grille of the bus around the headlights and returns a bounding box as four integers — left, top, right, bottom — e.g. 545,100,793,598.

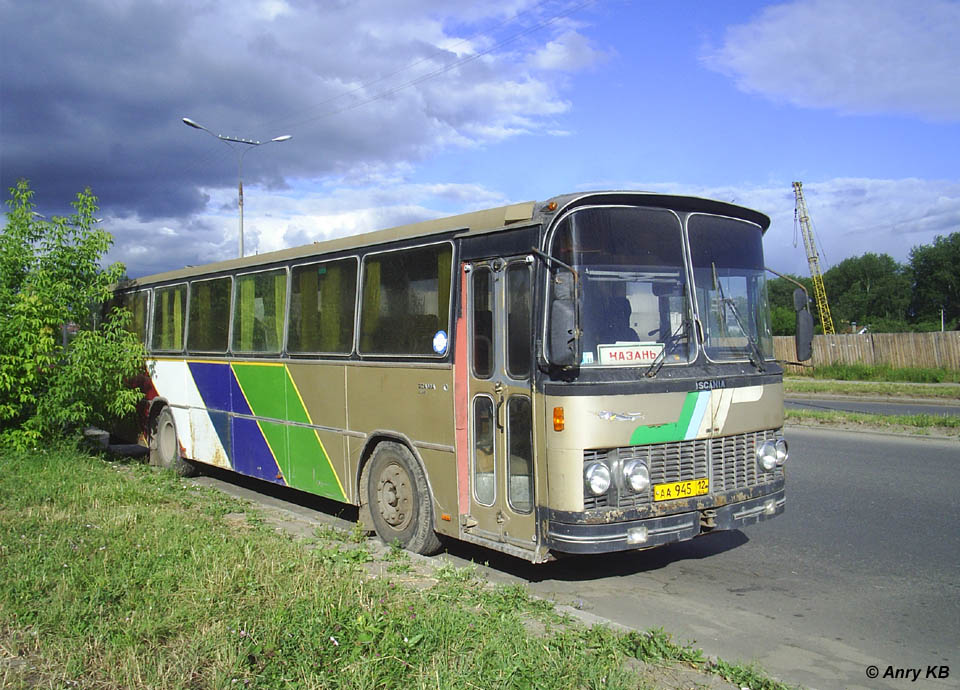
583,429,783,510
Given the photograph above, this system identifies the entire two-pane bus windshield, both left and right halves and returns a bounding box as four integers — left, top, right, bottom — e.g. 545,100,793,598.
552,206,773,369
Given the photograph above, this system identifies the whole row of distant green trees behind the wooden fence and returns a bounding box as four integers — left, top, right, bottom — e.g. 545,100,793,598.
768,232,960,335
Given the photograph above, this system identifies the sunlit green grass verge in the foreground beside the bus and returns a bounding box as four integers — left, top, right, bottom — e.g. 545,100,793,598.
0,451,785,689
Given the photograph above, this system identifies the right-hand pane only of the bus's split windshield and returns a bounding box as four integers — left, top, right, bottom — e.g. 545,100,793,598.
687,214,773,366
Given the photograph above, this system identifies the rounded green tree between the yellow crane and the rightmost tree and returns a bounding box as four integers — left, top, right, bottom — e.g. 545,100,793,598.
823,252,910,330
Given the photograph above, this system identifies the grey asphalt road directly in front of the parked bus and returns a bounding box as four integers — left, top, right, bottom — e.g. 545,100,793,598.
442,429,960,688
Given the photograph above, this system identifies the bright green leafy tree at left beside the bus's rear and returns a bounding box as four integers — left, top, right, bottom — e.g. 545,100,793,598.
0,180,145,448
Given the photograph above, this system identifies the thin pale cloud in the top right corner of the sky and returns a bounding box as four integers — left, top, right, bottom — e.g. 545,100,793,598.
702,0,960,121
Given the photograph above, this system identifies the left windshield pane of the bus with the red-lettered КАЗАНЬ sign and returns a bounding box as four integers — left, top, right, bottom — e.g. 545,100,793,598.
552,207,696,367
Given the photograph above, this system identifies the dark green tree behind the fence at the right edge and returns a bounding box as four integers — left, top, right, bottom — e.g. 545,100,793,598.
909,232,960,329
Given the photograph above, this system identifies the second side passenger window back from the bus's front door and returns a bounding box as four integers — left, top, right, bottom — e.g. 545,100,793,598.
287,259,357,354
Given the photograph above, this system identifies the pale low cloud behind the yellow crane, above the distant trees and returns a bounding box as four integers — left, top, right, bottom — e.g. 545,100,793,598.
627,178,960,275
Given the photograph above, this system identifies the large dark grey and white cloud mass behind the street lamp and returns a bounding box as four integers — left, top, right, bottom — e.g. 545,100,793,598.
0,0,589,224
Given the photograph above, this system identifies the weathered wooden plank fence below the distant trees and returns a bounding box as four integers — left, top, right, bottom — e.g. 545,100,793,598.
773,331,960,373
